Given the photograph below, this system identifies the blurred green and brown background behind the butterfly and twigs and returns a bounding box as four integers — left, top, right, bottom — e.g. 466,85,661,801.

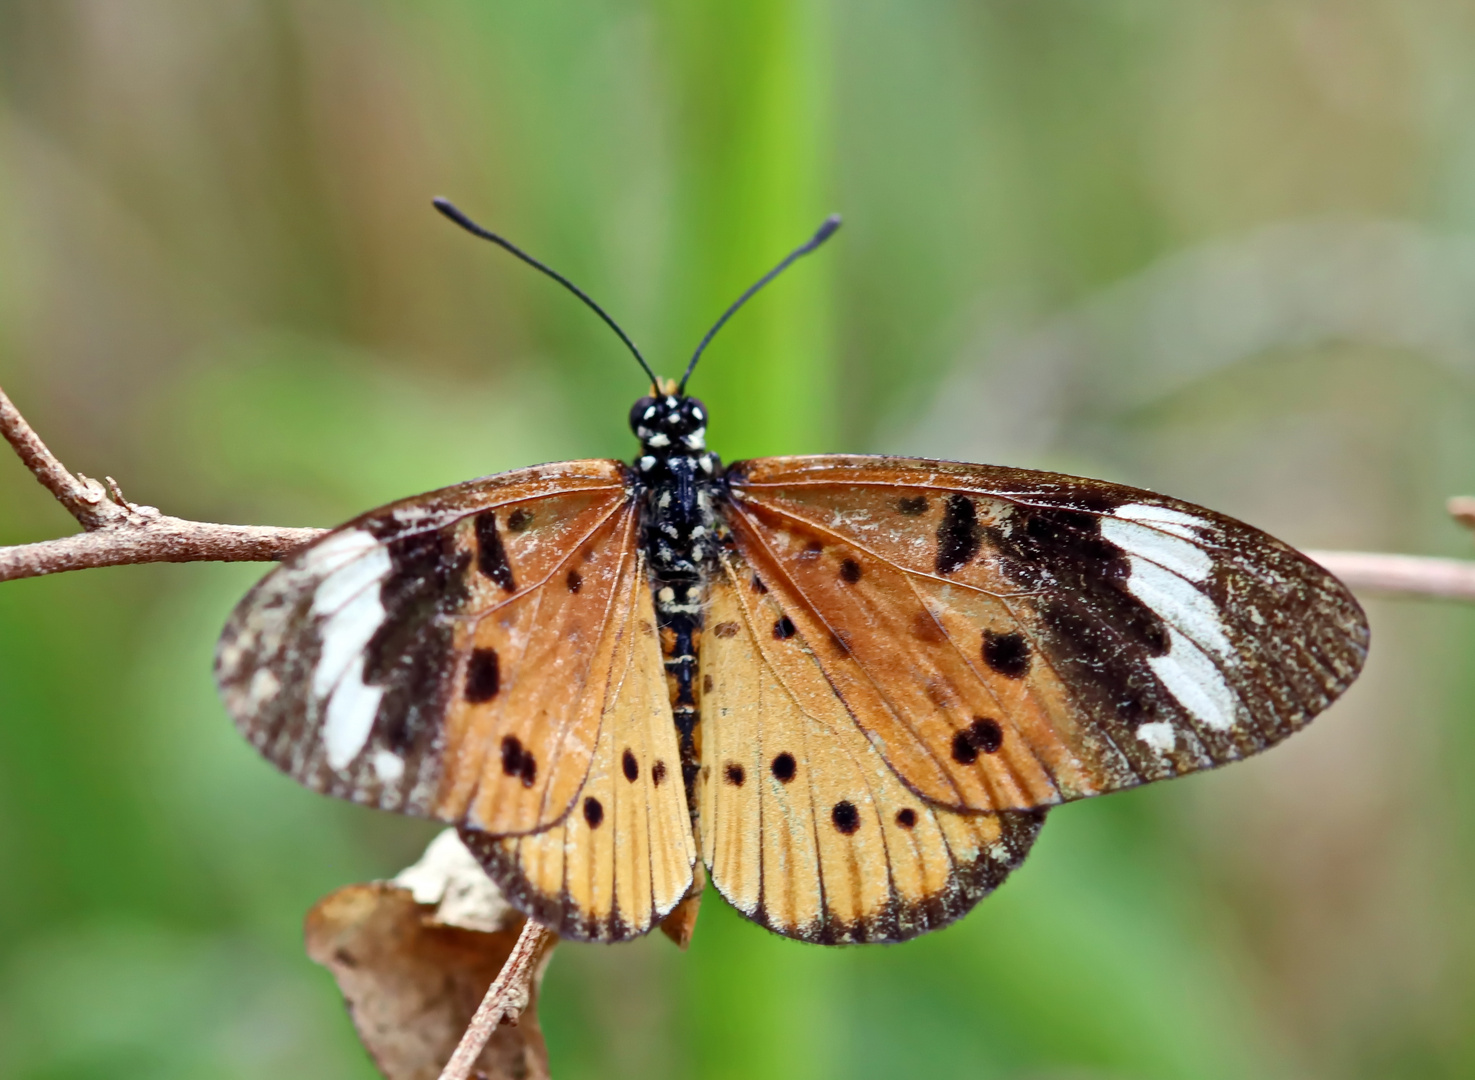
0,0,1475,1080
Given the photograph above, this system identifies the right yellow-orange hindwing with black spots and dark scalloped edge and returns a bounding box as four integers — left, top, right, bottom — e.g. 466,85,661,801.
701,552,1040,943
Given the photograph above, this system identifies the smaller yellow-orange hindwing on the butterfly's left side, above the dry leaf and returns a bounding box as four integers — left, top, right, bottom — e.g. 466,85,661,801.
462,567,696,941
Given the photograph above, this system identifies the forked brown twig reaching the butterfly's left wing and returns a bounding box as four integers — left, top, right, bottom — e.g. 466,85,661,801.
0,390,325,581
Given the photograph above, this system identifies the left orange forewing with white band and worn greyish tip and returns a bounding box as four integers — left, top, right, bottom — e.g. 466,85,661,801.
217,462,636,832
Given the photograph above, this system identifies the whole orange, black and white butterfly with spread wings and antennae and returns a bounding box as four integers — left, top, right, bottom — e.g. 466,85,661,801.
215,199,1369,943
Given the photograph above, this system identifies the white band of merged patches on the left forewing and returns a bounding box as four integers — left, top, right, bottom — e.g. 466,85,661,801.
305,528,403,769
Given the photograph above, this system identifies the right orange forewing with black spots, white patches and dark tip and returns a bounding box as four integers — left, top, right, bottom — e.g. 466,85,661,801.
729,456,1367,810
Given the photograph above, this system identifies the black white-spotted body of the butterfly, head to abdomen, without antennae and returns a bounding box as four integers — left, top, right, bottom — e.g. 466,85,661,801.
630,395,723,820
